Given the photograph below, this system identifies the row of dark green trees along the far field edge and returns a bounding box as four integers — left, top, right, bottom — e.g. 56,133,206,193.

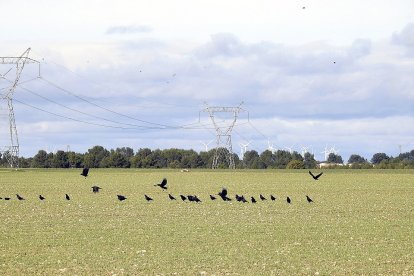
0,146,414,169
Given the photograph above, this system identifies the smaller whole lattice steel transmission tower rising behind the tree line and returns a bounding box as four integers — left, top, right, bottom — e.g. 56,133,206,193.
201,102,244,169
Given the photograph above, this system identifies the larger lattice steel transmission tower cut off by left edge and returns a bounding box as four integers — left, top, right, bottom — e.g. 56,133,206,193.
0,48,40,168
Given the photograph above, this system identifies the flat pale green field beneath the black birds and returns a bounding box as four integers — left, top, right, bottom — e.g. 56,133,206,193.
0,169,414,275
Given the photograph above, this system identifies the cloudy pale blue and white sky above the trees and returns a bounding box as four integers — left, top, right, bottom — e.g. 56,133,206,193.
0,0,414,162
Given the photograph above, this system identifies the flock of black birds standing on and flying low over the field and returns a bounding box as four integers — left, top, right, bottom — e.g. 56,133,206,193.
0,168,323,204
